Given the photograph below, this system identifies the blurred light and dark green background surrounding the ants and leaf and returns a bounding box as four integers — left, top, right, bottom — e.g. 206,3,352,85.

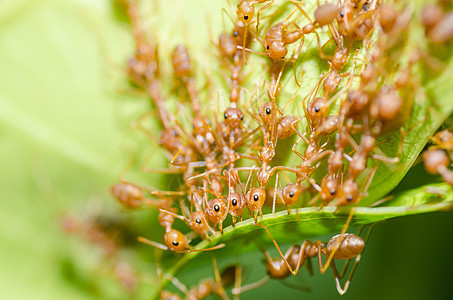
0,0,453,299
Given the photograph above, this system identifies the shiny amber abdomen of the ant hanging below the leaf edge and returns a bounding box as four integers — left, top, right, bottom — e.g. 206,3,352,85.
326,233,365,259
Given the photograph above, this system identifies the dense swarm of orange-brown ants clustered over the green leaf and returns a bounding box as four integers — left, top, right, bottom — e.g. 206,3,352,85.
96,0,453,299
